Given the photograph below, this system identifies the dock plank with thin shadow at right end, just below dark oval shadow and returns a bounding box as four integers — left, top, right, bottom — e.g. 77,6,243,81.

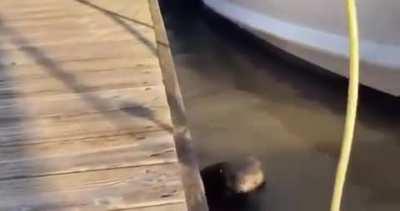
0,108,172,145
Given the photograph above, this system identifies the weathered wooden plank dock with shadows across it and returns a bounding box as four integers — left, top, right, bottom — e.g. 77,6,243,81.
0,0,205,211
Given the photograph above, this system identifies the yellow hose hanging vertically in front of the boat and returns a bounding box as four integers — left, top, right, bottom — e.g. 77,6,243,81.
330,0,360,211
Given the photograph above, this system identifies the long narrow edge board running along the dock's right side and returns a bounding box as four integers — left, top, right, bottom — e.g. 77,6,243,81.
149,0,208,211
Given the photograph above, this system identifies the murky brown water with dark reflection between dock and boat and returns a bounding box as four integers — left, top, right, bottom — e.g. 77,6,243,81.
161,1,400,211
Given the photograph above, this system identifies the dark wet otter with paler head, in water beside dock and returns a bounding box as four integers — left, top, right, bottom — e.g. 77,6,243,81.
201,157,265,203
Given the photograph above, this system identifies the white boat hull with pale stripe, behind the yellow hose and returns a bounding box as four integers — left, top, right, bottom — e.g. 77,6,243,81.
203,0,400,96
